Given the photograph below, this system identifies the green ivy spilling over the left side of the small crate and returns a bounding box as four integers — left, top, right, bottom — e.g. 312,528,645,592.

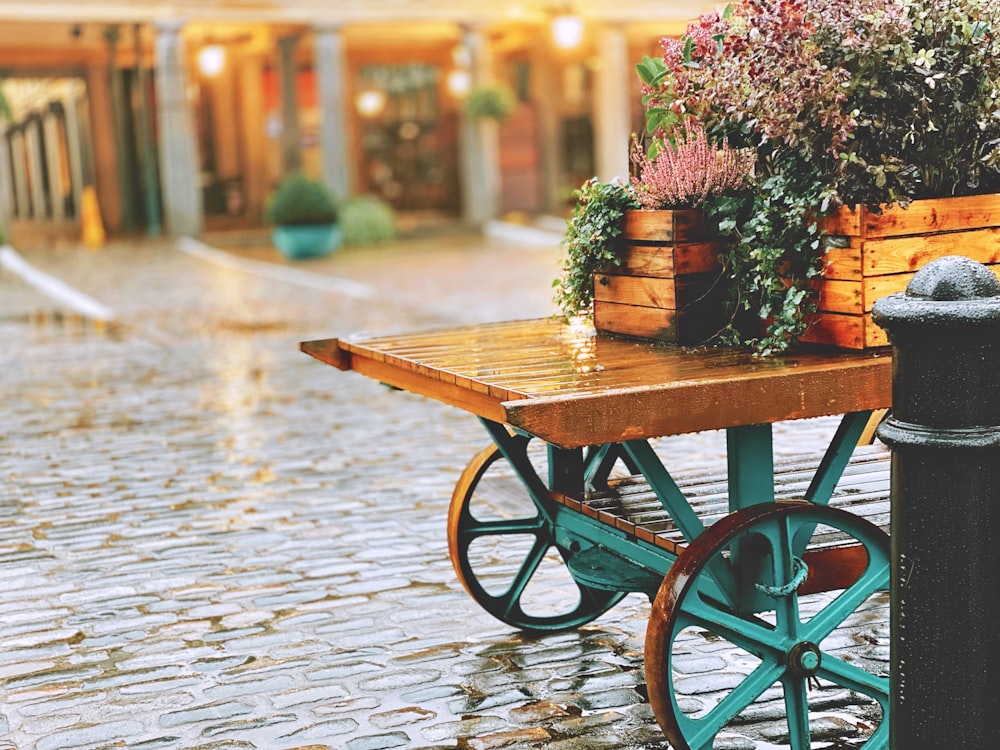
553,178,639,316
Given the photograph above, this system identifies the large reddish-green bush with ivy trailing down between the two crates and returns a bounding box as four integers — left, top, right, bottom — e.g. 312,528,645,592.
637,0,1000,354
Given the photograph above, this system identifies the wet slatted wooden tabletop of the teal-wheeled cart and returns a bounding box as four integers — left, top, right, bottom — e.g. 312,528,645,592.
301,318,892,448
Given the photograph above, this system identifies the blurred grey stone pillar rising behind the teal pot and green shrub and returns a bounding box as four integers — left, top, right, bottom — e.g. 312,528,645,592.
314,26,354,199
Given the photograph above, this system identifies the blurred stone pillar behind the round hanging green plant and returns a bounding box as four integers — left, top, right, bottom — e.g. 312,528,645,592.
460,29,500,224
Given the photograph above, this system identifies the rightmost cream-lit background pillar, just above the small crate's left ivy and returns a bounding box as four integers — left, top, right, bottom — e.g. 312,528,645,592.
594,26,632,182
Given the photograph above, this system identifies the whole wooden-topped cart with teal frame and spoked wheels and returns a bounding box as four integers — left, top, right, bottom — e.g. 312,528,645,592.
302,319,891,750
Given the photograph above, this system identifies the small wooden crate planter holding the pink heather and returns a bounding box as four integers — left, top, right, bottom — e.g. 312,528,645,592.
594,210,726,344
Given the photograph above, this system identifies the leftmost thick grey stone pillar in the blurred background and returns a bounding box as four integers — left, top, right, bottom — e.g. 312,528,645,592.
156,22,204,236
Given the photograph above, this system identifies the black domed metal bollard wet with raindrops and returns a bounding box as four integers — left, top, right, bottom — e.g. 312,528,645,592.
873,256,1000,750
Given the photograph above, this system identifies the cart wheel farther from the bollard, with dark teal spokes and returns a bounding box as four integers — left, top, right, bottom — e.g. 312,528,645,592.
448,445,625,631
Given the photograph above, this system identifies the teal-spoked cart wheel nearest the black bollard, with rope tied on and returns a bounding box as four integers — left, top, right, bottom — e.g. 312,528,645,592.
645,502,890,750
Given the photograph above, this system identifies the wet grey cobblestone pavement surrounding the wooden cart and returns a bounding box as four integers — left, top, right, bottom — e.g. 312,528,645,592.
0,235,884,750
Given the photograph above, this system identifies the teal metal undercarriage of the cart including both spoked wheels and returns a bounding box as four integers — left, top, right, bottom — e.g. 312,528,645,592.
459,411,889,750
